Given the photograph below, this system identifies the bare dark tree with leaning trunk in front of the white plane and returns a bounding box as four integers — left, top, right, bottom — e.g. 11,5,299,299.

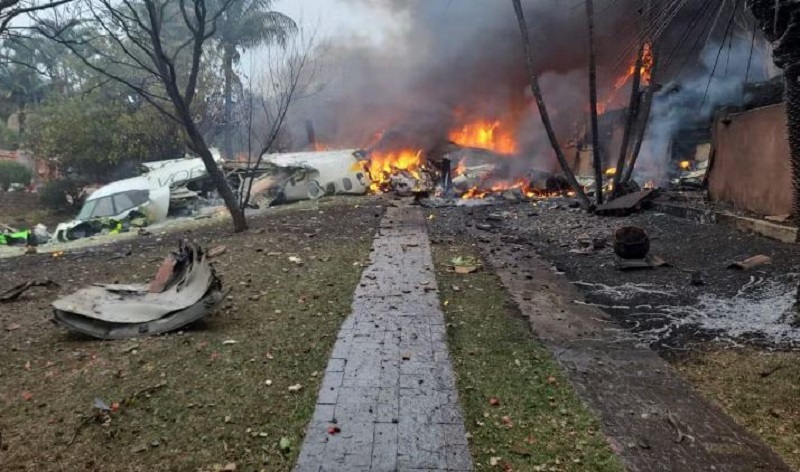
37,0,253,232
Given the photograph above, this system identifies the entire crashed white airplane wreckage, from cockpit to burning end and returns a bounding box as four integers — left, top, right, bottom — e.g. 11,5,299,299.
47,143,580,249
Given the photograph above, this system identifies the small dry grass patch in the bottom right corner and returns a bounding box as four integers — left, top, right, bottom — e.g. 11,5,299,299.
677,349,800,471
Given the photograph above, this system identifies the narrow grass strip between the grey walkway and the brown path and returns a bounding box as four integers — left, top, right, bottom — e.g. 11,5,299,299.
434,244,622,471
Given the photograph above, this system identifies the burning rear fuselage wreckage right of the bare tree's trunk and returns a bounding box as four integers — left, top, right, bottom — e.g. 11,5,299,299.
241,143,566,206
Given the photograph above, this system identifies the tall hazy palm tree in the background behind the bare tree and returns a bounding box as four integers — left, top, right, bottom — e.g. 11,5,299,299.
217,0,297,159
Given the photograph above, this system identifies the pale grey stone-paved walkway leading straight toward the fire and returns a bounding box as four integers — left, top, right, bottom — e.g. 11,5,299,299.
295,207,472,472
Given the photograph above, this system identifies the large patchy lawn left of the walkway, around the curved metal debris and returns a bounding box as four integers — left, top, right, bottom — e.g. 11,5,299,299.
0,200,383,471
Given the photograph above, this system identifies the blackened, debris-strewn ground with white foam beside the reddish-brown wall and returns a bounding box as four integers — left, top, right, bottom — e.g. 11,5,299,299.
430,199,800,350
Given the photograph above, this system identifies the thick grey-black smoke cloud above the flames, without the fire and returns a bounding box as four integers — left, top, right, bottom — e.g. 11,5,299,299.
291,0,768,174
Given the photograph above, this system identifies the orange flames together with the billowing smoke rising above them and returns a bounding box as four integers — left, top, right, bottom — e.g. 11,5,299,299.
278,0,780,198
